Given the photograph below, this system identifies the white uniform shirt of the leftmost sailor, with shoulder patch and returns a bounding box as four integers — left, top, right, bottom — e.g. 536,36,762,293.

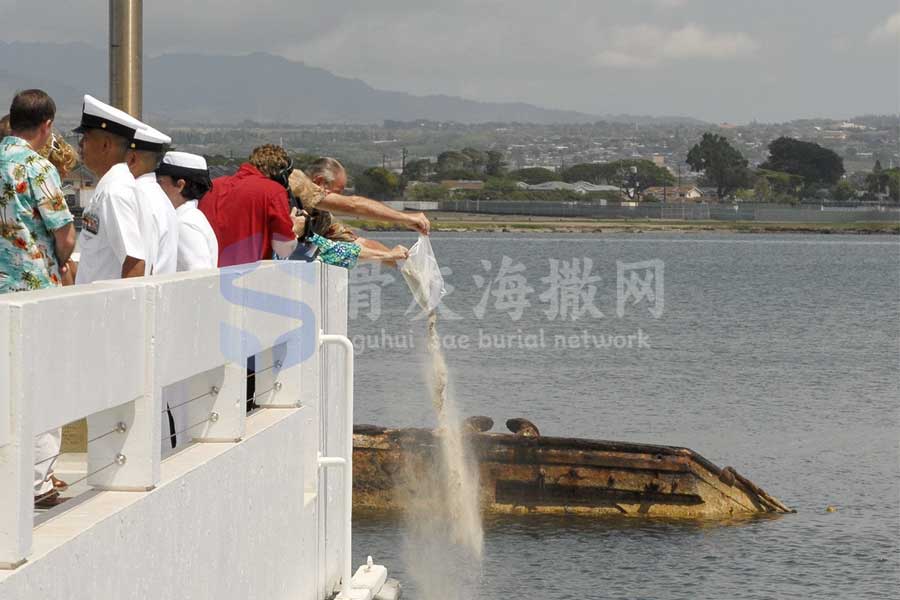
75,163,150,283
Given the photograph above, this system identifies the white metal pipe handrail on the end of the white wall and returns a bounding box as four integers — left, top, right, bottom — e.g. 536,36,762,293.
319,333,353,600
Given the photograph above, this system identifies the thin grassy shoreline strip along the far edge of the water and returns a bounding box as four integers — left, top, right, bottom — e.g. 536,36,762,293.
344,213,900,235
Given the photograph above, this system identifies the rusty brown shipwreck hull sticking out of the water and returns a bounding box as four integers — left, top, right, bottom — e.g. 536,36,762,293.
353,425,793,519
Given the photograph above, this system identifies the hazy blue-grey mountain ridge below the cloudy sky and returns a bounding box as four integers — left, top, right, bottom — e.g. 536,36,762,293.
0,42,700,125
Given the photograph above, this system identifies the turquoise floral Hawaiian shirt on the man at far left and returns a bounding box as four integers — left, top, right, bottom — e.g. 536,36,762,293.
0,136,72,294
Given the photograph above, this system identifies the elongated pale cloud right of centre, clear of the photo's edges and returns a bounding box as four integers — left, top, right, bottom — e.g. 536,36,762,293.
594,25,759,68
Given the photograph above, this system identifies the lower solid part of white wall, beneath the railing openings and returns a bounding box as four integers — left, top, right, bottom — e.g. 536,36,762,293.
0,408,322,600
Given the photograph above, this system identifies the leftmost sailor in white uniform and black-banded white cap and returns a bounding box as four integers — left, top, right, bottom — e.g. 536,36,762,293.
75,95,150,283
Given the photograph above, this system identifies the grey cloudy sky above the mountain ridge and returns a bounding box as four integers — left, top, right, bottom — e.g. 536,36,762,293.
0,0,900,122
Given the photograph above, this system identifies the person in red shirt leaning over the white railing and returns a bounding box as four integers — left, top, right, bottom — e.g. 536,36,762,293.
200,144,305,267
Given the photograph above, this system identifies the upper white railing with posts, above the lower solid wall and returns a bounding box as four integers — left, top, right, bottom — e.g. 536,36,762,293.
0,262,352,596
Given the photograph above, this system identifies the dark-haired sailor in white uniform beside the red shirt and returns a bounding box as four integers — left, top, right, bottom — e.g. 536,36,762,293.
156,152,219,271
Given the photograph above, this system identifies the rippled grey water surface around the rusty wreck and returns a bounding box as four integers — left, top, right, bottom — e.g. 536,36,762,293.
350,234,900,600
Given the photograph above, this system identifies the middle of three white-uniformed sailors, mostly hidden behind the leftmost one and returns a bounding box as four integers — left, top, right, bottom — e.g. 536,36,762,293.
128,123,178,275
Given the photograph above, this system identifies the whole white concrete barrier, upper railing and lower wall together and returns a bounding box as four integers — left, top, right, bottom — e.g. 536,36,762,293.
0,263,350,600
